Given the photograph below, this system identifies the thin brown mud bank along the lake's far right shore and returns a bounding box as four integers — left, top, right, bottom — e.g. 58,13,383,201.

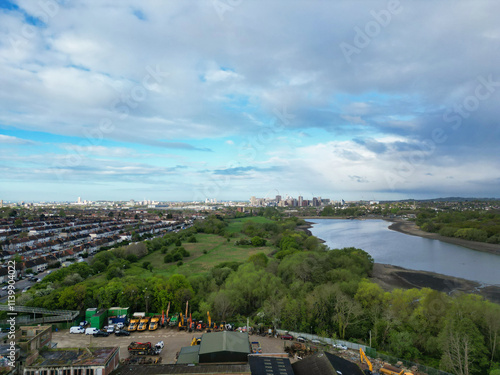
390,219,500,255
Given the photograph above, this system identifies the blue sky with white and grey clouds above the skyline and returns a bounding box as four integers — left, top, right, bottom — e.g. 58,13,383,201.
0,0,500,202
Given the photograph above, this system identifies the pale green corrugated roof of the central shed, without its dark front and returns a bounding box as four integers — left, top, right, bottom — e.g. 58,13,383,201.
200,331,252,354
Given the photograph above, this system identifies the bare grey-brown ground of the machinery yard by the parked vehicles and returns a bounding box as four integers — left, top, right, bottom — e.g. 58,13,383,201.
52,328,290,363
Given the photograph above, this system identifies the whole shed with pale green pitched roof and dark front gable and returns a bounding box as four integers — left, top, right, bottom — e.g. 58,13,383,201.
199,331,252,363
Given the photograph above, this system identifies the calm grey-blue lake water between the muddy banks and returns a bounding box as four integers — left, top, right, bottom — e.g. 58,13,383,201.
308,219,500,286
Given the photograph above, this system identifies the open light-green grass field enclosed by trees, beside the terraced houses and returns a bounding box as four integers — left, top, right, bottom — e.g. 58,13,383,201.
125,217,273,278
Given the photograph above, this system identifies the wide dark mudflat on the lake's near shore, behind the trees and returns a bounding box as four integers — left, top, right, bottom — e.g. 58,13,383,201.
370,263,500,304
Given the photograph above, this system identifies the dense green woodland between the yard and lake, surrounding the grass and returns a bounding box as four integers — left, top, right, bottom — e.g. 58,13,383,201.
11,216,500,374
